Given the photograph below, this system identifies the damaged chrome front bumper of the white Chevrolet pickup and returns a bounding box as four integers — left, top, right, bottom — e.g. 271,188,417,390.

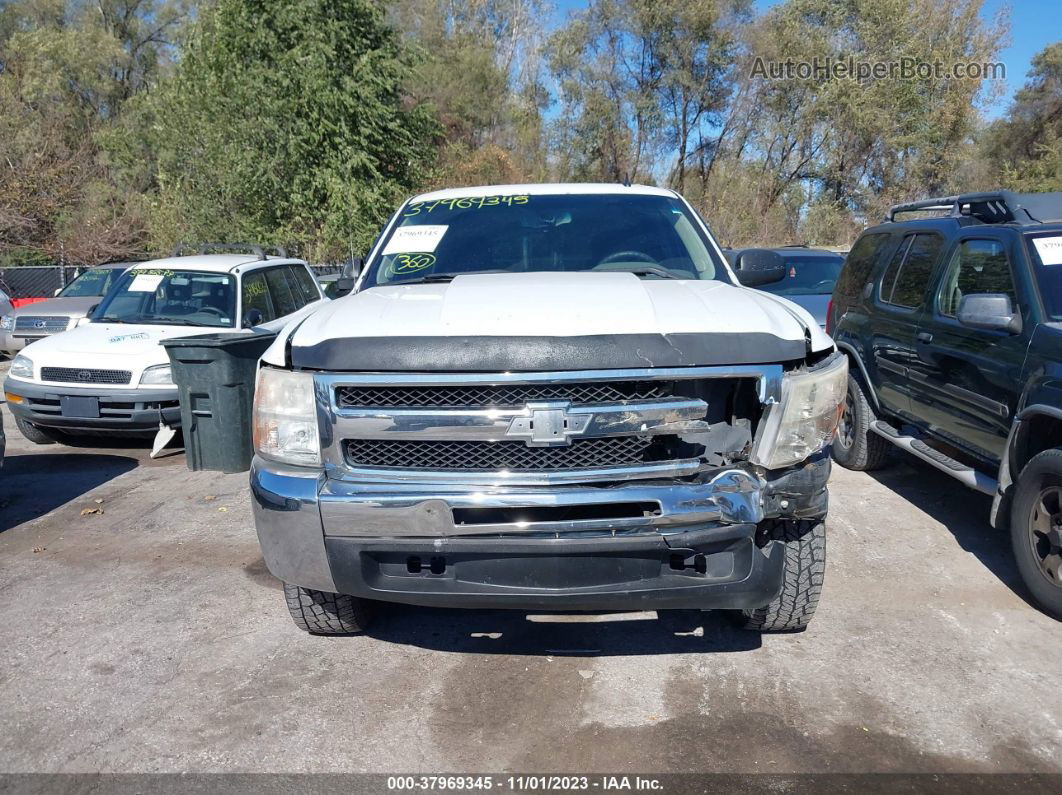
251,451,829,609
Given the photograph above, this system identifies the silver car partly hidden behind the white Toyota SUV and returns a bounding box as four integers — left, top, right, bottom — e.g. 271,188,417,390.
0,262,135,355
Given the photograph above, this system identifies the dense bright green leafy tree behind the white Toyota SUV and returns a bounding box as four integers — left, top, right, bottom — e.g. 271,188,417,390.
139,0,436,260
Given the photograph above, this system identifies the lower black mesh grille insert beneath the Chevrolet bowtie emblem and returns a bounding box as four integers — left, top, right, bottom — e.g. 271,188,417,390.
344,436,660,472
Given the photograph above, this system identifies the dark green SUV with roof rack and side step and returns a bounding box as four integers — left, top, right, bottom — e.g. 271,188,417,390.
828,191,1062,619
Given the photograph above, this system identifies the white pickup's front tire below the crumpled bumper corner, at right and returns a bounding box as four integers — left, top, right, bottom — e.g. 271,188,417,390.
743,520,826,633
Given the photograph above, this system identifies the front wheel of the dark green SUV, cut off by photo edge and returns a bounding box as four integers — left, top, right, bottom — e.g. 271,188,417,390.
1010,450,1062,620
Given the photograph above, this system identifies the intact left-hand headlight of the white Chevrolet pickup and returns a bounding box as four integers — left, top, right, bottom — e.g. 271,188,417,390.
254,367,321,466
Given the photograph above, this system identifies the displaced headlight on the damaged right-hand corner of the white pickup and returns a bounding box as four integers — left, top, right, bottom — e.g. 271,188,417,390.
750,353,849,469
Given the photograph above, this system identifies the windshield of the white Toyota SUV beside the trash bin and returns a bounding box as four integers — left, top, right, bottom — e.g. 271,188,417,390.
92,267,236,327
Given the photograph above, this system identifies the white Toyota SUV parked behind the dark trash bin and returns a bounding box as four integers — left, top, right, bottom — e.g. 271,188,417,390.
4,246,325,444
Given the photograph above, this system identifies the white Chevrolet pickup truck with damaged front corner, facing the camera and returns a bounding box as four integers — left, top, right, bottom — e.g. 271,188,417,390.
252,185,847,634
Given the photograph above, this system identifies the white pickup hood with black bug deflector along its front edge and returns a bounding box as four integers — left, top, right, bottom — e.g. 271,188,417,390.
273,272,833,370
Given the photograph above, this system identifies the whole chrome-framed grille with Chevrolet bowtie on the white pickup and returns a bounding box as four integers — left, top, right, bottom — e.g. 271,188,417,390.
315,365,782,488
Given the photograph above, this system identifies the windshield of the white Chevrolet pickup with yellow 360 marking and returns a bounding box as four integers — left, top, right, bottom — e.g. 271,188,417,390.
362,193,729,289
